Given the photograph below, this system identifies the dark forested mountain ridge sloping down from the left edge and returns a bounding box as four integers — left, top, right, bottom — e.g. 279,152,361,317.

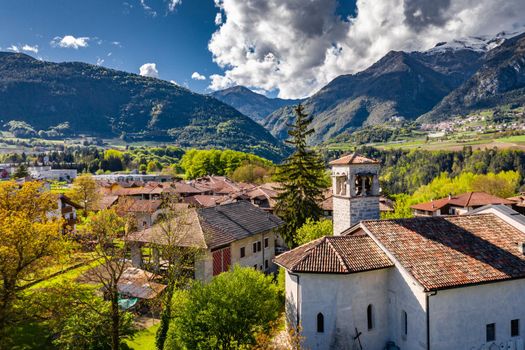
0,52,286,160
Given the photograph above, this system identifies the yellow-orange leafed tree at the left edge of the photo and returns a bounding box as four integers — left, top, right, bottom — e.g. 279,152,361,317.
0,181,66,348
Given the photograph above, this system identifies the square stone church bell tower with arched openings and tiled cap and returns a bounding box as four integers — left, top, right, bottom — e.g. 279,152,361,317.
330,154,380,236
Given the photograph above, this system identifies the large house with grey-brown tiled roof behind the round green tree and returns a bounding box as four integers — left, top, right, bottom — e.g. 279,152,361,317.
127,201,282,281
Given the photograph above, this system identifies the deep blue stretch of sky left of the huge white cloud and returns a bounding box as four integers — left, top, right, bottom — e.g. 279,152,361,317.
0,0,221,91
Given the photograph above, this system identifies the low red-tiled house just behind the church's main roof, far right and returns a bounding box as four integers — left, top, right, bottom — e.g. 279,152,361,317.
410,192,513,216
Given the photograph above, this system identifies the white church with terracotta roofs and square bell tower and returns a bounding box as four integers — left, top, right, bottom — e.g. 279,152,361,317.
275,155,525,350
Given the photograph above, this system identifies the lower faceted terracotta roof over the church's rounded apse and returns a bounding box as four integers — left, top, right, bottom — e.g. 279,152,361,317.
275,235,393,273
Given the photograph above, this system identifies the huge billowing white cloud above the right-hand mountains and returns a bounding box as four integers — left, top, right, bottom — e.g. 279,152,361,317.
208,0,525,98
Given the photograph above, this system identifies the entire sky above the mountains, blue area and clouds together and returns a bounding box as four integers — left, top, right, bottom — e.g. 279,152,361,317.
0,0,525,98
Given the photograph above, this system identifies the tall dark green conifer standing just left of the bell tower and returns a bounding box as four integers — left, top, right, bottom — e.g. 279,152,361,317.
275,105,326,248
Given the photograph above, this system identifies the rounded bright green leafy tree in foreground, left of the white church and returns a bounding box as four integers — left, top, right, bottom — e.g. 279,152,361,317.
166,266,282,350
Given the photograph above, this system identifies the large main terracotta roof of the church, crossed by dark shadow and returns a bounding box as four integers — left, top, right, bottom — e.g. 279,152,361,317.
361,214,525,290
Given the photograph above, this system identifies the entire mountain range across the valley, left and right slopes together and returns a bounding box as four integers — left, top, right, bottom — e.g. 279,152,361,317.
0,29,525,160
